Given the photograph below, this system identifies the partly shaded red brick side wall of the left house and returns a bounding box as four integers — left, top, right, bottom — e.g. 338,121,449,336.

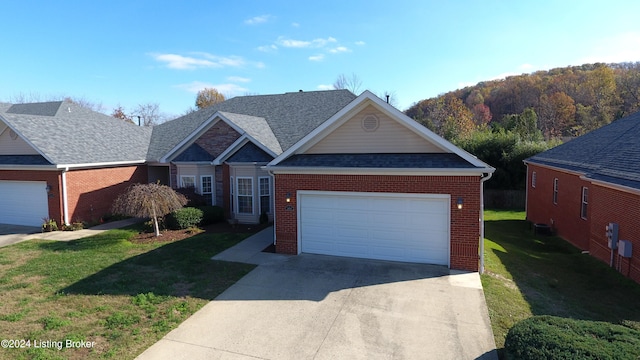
66,166,148,221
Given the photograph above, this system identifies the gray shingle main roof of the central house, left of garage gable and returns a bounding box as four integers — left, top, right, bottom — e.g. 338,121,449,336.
147,90,356,160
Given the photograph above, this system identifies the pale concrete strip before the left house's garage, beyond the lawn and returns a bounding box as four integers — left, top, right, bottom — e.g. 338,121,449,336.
0,218,143,247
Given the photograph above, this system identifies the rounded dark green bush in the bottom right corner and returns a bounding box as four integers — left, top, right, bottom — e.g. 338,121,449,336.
504,315,640,360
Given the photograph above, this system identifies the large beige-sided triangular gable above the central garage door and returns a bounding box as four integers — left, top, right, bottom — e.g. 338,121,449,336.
267,91,494,172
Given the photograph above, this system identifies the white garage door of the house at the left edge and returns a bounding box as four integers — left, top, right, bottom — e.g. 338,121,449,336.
0,181,49,226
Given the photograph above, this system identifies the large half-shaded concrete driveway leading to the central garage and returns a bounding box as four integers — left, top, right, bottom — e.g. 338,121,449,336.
138,254,497,360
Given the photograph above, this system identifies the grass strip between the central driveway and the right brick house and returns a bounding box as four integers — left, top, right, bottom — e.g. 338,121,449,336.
481,210,640,353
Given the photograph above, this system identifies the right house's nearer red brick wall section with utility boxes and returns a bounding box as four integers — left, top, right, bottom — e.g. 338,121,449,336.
589,185,640,283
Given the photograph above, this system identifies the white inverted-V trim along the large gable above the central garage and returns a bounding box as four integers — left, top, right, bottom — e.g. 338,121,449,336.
267,90,495,173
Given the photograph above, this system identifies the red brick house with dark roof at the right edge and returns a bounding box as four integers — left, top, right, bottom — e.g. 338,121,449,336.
525,112,640,282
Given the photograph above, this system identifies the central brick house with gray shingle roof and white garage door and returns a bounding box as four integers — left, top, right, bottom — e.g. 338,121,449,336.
0,90,494,271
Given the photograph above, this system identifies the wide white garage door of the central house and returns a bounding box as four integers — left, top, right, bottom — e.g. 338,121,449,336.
298,191,450,265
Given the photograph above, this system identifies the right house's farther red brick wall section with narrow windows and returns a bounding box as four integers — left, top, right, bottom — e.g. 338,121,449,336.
527,164,594,250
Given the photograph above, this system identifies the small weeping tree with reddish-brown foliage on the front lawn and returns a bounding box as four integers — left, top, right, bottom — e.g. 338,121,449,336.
112,184,187,236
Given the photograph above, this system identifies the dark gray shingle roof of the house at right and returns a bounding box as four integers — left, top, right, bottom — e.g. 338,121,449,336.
526,112,640,189
